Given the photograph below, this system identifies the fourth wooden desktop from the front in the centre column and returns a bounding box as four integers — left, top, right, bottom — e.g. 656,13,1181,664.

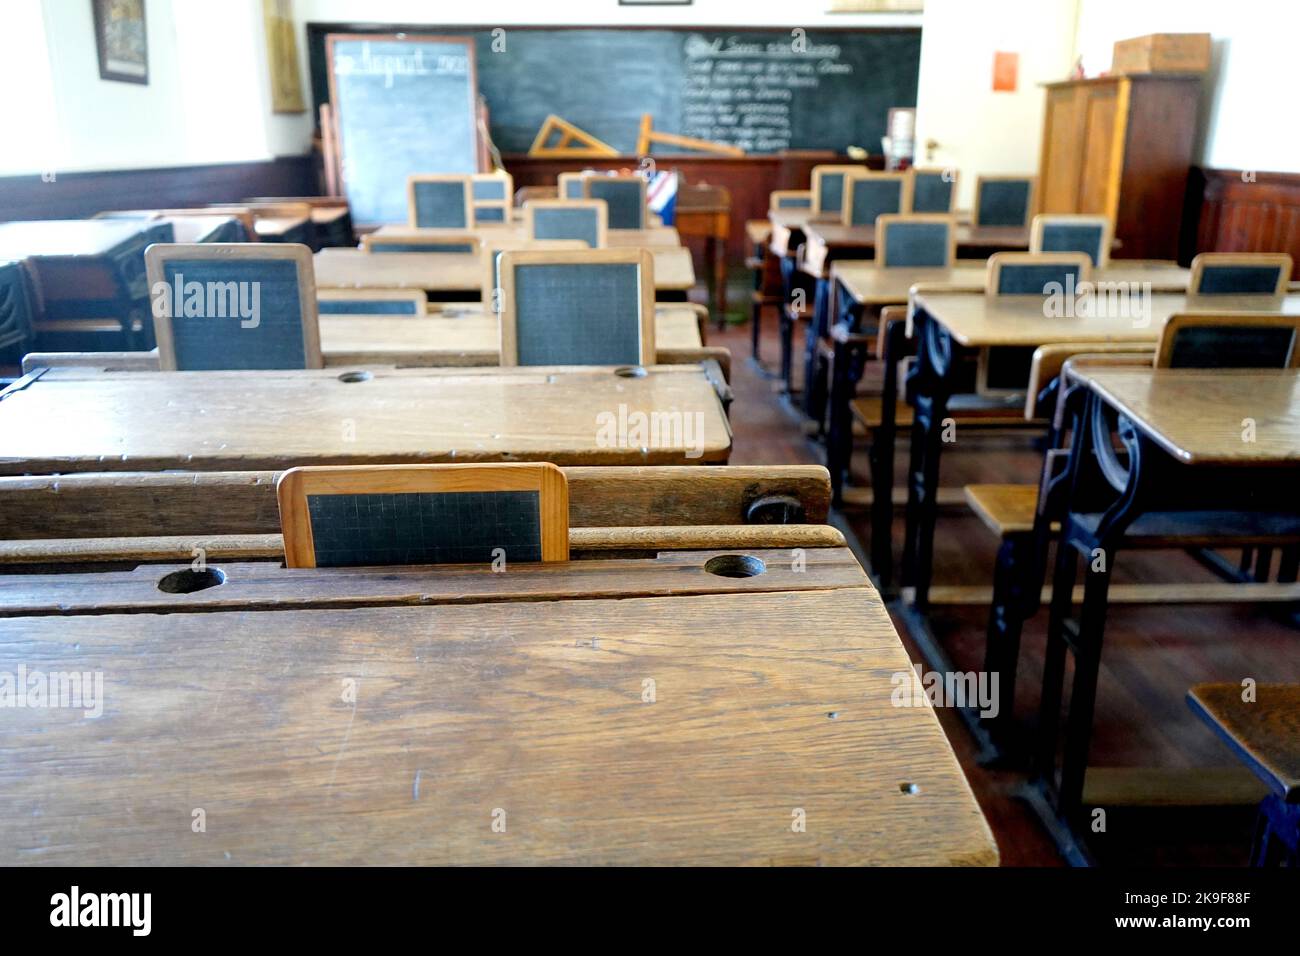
315,246,696,300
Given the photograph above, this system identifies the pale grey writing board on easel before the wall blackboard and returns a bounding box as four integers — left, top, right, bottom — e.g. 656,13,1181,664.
325,34,481,225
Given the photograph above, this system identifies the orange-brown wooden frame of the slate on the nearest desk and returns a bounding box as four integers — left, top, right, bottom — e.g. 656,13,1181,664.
276,462,568,567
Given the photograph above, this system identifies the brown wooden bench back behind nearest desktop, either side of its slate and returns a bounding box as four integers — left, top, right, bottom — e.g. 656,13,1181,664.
0,464,857,574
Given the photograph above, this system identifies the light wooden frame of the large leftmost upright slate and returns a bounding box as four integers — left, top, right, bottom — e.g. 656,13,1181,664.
144,242,325,372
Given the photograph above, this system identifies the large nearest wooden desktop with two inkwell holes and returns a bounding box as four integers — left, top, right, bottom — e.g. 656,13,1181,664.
0,548,998,866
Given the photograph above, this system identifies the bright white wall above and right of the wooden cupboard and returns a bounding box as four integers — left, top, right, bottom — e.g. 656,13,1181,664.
1078,0,1300,173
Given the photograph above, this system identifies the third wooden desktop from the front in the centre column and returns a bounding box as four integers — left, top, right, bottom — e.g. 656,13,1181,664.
319,307,703,367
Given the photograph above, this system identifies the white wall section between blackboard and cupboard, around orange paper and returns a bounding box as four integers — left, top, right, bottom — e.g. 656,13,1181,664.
917,0,1078,209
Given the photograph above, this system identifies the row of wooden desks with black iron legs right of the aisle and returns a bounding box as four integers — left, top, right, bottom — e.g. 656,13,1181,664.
768,211,1300,862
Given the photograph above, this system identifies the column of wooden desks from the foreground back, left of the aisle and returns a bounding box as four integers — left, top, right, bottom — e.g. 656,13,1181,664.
0,201,998,865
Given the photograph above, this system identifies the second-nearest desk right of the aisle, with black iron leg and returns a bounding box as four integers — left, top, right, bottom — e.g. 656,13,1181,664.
881,290,1300,610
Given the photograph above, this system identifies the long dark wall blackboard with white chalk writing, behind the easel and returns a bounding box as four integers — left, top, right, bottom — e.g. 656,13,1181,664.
308,23,920,158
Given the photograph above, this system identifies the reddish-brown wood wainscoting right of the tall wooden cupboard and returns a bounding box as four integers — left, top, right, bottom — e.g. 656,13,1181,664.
1184,169,1300,278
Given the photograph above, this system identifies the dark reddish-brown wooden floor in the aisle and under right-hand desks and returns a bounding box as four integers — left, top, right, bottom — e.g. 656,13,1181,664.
709,306,1300,866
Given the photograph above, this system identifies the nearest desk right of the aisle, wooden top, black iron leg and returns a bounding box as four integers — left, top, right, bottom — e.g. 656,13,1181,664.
1032,363,1300,862
